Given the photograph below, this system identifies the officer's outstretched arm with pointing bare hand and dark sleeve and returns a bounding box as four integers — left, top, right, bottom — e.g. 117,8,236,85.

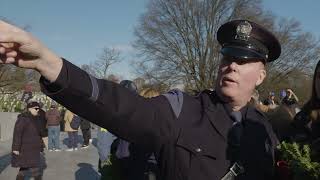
0,20,173,150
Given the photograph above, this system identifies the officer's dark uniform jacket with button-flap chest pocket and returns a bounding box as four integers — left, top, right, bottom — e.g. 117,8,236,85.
40,60,275,180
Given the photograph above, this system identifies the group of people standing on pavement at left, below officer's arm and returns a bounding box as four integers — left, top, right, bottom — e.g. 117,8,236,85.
12,99,91,180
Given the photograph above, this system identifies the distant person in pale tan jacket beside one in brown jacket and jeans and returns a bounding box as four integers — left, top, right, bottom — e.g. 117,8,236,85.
64,110,78,151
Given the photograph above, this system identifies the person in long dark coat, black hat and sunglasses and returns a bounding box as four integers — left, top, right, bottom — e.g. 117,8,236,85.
11,102,43,180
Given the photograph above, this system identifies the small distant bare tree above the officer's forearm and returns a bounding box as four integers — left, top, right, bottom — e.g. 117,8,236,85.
89,47,121,79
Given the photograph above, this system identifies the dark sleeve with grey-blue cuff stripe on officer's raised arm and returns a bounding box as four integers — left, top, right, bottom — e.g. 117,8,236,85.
40,60,175,149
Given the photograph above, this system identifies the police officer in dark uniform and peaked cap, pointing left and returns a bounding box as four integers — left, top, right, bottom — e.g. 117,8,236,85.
0,20,281,180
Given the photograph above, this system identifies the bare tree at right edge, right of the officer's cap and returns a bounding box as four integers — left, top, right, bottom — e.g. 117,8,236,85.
259,18,320,96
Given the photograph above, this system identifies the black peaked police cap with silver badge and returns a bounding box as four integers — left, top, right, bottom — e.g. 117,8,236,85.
217,20,281,63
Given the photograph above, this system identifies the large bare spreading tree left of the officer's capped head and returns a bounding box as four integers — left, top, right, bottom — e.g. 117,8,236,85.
134,0,260,90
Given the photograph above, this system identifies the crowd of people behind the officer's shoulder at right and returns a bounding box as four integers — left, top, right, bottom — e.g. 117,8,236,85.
251,61,320,160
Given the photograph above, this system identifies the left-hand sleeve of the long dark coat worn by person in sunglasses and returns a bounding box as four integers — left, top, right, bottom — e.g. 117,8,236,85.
12,117,25,151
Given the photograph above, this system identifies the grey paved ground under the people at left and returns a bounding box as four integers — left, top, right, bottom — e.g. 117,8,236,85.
0,131,100,180
